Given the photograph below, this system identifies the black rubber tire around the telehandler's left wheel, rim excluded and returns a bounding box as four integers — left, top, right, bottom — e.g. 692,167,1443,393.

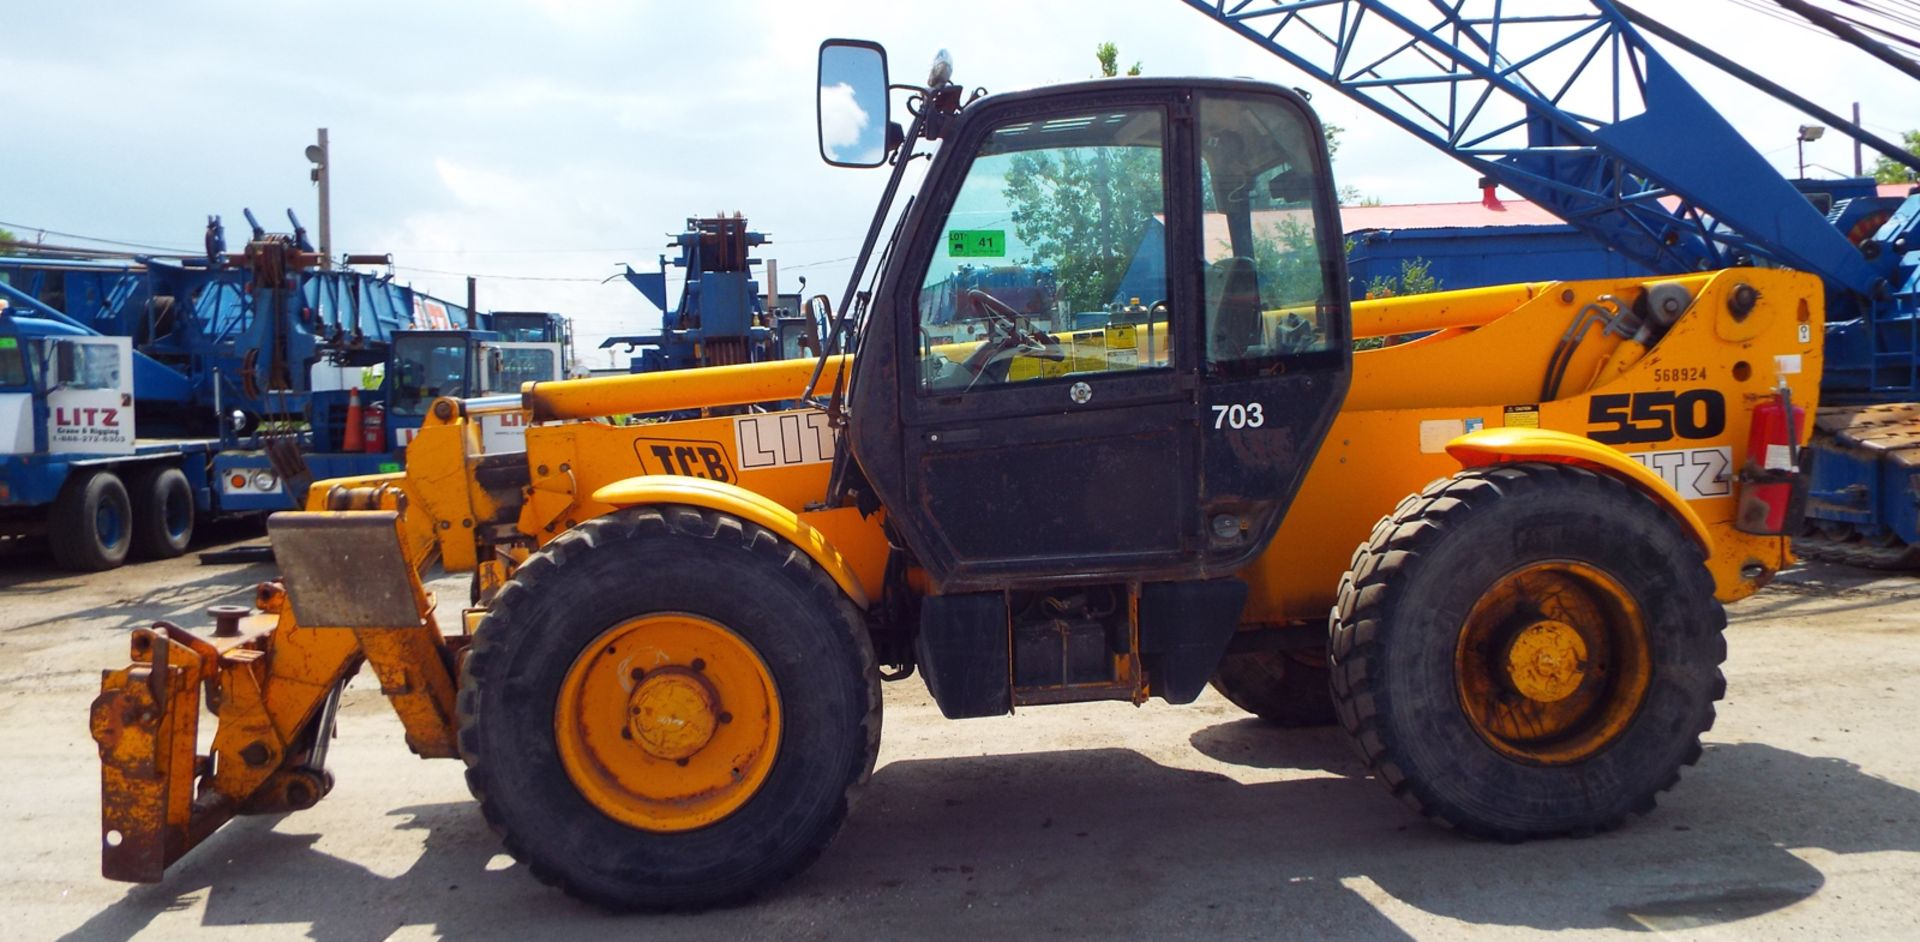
459,506,881,909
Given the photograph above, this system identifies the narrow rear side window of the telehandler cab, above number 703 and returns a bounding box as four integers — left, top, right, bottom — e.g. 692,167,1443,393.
1200,92,1344,372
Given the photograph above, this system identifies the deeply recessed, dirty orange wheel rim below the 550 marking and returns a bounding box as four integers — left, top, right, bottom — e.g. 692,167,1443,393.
1453,562,1653,765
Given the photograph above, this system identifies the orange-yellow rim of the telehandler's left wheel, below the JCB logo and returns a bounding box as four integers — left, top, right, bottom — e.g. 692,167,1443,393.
553,612,780,831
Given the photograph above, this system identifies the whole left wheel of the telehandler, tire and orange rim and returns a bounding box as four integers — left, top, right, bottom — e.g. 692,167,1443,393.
459,506,879,909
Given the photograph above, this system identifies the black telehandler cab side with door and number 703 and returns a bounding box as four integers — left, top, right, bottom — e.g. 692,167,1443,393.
851,82,1348,591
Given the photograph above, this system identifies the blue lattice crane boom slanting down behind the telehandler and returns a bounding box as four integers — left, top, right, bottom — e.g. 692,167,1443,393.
1185,0,1885,297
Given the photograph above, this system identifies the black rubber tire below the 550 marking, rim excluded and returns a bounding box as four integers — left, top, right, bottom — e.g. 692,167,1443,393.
1331,464,1726,840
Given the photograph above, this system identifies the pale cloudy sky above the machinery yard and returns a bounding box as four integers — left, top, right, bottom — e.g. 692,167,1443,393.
0,0,1920,365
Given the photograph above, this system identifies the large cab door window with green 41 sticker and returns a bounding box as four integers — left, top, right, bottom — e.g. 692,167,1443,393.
918,107,1171,393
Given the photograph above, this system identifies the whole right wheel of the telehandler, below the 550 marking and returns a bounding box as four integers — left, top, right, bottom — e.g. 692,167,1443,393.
1331,464,1726,840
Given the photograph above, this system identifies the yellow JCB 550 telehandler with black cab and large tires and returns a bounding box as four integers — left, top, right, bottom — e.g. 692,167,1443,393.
92,40,1822,909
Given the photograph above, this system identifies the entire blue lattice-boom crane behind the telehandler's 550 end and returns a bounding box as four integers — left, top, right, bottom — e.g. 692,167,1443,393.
1183,0,1920,566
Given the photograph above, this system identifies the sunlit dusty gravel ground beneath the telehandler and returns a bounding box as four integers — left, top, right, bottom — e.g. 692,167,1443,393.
0,530,1920,940
